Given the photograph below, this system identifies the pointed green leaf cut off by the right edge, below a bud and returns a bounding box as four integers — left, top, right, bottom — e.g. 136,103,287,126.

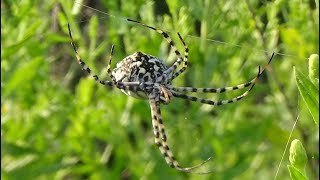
293,67,319,125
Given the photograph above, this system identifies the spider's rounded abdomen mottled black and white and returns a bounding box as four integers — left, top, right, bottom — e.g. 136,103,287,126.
112,52,168,98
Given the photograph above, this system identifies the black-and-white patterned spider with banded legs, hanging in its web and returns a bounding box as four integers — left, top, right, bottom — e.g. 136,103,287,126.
68,19,274,172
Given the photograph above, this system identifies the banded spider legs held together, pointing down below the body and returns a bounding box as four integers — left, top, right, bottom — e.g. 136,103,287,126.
149,95,211,174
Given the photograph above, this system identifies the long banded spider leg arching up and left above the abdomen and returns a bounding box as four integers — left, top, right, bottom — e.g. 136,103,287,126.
127,19,184,79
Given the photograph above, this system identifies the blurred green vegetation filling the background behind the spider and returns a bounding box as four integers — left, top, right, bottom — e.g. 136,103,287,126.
1,0,319,179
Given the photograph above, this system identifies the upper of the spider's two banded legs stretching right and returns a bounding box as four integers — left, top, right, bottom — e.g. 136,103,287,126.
172,53,274,93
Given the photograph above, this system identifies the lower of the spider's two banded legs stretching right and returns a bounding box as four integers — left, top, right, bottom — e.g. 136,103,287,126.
172,66,261,106
